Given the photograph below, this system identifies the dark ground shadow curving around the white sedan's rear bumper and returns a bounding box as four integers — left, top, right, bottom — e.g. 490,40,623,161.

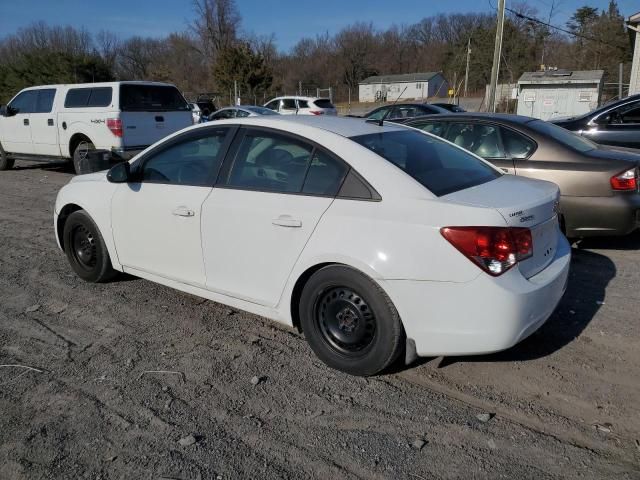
408,244,616,368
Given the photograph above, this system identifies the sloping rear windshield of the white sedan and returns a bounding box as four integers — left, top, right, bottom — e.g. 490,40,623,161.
351,130,502,197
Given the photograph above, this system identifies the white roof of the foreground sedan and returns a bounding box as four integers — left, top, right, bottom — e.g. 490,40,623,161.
195,115,405,138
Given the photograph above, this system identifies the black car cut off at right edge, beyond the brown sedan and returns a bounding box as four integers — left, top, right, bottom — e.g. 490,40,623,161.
551,95,640,148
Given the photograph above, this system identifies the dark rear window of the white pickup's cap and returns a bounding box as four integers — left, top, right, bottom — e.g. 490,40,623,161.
120,84,190,112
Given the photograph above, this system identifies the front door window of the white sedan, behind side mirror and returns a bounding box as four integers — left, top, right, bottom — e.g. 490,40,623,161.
138,128,229,187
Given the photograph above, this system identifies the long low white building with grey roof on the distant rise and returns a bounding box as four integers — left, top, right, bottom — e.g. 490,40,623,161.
358,72,449,102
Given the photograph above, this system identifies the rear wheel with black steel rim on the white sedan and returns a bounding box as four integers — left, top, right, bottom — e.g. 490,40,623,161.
299,265,405,376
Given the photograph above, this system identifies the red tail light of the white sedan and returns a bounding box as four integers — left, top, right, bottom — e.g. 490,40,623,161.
440,227,533,277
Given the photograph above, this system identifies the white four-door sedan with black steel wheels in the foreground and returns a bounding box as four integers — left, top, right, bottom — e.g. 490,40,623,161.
55,116,571,375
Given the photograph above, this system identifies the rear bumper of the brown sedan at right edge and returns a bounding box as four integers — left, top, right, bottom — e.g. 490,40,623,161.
560,192,640,237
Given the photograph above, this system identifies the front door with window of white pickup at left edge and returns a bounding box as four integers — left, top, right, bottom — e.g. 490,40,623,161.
2,90,38,154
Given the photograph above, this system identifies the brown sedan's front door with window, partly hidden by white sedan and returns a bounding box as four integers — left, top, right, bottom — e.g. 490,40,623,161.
445,122,516,174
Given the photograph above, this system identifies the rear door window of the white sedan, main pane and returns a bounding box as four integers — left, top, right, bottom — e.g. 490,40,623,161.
226,132,313,193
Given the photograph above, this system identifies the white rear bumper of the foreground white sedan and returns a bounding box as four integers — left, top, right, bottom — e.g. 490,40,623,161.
380,236,571,356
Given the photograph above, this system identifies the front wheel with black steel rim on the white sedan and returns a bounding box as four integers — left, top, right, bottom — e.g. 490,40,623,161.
62,210,117,283
